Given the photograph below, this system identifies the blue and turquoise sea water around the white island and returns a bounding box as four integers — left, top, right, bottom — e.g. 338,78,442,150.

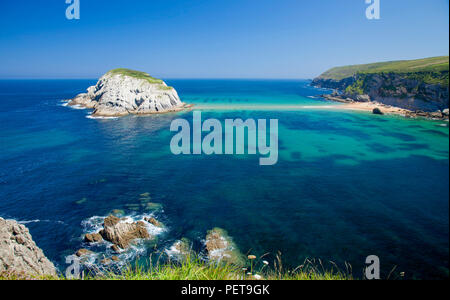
0,80,449,278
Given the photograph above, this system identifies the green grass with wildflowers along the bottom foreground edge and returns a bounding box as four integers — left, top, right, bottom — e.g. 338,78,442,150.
0,258,352,280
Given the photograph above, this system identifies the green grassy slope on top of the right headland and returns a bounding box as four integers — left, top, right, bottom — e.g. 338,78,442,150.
318,56,449,84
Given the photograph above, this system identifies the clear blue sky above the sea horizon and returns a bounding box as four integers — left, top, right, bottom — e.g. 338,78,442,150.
0,0,449,78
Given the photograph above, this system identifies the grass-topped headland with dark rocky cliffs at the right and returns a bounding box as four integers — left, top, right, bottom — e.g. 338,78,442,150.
312,56,449,112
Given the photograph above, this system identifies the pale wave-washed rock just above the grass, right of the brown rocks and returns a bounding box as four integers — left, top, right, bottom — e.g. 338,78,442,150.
205,228,244,265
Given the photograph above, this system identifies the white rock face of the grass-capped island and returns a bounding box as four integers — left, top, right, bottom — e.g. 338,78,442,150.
69,71,185,117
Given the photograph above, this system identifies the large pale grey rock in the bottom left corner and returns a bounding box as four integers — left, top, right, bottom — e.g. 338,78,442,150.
0,218,56,276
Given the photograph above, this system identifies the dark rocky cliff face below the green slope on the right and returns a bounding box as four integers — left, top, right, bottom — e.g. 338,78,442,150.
312,73,449,112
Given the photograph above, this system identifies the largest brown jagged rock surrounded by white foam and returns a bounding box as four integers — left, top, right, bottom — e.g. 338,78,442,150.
100,215,150,249
